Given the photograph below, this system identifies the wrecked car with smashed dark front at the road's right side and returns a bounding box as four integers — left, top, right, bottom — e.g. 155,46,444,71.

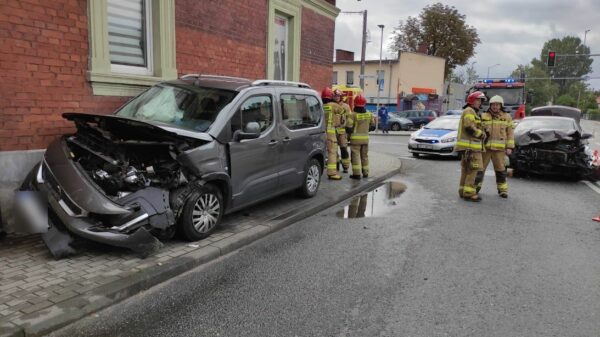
510,107,597,179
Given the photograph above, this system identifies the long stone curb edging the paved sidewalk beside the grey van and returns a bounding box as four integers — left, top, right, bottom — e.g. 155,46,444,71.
0,154,401,337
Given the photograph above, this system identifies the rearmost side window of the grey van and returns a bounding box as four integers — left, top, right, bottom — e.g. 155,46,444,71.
281,94,322,130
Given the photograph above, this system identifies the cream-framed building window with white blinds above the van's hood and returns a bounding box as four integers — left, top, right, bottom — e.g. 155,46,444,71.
87,0,177,96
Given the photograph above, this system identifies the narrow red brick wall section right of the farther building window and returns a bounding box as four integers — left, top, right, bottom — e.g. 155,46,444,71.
300,7,335,92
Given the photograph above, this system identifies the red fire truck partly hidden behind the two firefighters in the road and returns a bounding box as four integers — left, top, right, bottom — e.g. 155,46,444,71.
467,78,526,119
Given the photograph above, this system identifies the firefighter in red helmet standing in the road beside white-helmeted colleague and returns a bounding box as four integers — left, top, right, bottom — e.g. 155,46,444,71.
455,91,486,201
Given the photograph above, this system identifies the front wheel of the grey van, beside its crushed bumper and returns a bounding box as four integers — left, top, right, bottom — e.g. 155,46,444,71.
179,184,224,241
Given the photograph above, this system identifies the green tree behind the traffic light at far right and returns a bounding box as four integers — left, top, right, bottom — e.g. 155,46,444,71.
540,36,593,95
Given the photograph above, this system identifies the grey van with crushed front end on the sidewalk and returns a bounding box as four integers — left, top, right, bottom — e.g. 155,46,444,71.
15,75,325,257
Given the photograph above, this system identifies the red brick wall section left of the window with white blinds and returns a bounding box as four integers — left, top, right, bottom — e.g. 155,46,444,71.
0,0,123,151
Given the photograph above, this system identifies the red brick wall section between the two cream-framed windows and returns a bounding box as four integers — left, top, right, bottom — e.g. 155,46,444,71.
175,0,267,79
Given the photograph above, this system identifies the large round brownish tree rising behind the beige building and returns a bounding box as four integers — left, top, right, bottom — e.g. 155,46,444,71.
390,3,481,78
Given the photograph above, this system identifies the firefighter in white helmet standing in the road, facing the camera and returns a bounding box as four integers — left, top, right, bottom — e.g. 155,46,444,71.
476,95,515,198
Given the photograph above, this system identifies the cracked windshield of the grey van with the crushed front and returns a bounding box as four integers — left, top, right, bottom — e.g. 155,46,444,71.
115,84,236,132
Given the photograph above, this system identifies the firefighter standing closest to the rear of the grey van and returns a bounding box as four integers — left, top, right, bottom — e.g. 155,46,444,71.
321,87,343,180
